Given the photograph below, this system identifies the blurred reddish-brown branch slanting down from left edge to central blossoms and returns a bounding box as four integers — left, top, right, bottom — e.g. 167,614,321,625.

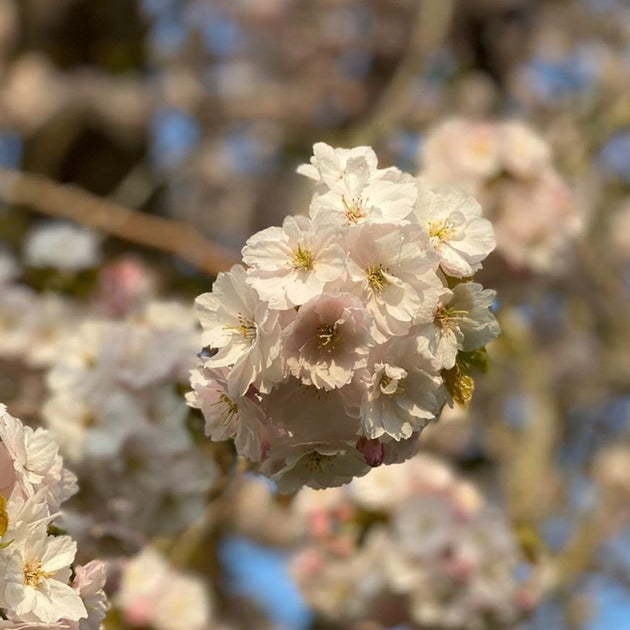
0,168,239,276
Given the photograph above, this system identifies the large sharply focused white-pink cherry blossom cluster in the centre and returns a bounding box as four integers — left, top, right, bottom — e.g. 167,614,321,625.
188,143,498,492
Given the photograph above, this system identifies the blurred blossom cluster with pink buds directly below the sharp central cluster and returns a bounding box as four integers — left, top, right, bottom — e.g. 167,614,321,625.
290,456,546,630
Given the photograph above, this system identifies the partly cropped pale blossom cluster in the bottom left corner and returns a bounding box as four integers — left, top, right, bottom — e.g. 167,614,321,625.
0,405,107,630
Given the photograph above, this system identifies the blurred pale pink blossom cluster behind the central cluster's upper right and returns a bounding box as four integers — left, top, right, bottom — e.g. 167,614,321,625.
420,118,584,273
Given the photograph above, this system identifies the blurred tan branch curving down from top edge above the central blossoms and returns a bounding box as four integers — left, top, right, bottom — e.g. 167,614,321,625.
344,0,455,146
